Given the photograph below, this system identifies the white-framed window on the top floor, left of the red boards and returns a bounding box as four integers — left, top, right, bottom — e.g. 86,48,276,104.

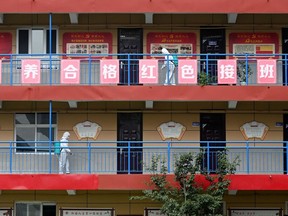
18,28,57,54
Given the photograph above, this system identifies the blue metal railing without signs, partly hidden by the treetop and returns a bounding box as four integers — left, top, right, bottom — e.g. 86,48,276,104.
0,141,288,174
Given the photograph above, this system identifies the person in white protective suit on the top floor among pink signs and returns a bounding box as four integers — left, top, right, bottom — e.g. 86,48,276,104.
161,48,176,85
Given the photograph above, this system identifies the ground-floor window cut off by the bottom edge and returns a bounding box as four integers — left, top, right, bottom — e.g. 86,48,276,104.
15,202,56,216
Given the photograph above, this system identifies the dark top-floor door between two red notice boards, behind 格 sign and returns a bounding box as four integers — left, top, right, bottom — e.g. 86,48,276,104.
118,28,143,85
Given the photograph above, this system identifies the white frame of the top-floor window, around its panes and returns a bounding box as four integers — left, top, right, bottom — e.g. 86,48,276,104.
16,26,59,55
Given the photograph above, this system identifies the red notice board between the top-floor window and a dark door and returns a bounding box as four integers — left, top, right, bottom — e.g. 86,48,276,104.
63,32,112,58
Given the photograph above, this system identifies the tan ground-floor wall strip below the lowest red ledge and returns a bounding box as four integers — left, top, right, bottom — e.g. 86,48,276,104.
0,191,287,215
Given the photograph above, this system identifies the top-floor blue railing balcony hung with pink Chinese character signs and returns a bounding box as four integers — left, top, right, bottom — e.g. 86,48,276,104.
0,53,288,86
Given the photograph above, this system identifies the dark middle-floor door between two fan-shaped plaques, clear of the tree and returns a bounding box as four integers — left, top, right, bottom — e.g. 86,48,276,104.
117,113,143,174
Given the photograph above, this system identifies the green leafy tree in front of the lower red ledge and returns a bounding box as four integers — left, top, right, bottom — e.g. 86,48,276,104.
131,151,240,216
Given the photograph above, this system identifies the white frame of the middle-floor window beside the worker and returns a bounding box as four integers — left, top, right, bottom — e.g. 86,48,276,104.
14,112,58,154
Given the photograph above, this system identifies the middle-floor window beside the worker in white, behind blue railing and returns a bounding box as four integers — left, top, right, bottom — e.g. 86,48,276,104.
15,113,57,153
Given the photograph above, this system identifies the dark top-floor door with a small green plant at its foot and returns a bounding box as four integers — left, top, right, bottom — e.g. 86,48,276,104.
200,28,226,82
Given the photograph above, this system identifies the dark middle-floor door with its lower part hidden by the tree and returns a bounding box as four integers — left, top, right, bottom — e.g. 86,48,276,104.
200,113,226,173
